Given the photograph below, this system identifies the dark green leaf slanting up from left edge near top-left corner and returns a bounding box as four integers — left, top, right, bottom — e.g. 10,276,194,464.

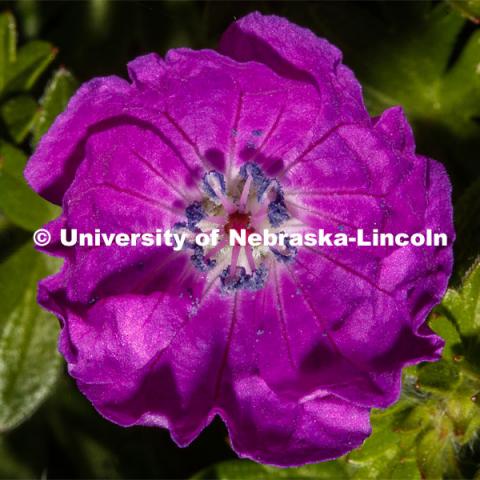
2,40,57,95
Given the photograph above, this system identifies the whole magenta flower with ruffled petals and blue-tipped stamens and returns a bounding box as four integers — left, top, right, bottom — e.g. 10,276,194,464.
26,13,454,466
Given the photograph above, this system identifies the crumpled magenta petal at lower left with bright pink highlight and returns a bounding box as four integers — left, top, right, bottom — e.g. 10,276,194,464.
68,286,233,445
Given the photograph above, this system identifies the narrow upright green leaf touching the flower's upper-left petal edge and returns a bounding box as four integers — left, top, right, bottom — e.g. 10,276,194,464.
33,68,78,145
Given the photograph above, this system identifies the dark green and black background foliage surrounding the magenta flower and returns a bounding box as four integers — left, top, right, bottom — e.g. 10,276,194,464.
0,0,480,478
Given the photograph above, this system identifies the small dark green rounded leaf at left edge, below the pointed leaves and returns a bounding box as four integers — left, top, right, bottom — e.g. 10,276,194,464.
0,95,38,143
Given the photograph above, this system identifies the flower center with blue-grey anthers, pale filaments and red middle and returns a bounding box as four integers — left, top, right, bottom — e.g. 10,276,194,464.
175,163,296,293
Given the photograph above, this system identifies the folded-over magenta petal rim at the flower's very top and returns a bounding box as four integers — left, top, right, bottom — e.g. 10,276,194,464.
220,12,369,122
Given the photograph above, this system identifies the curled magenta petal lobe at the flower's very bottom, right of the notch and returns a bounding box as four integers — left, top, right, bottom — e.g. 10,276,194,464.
222,377,371,467
